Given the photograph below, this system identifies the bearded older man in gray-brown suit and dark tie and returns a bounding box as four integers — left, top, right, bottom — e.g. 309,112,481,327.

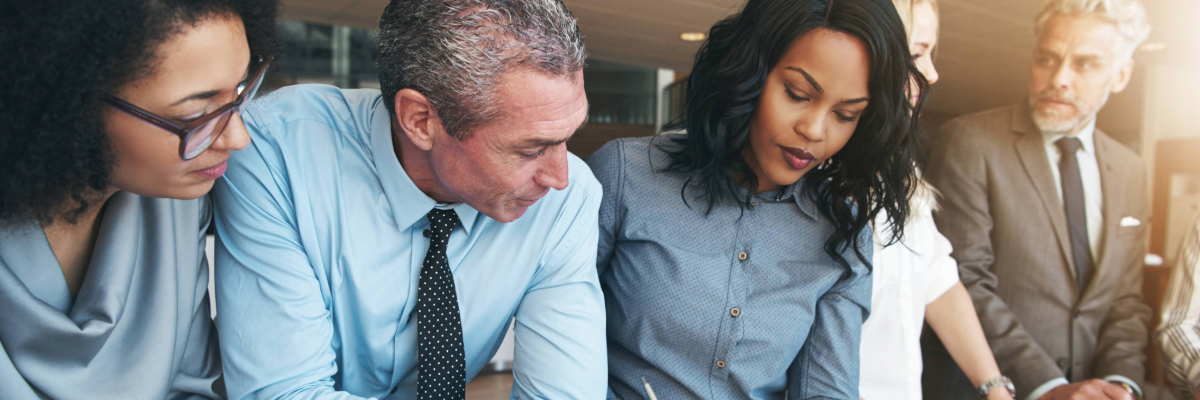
924,0,1151,400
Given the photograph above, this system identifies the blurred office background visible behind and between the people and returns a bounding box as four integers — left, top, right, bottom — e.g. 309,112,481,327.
204,0,1200,399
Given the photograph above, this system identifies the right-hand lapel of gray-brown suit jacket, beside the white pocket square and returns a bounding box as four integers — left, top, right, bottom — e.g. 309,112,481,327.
1085,130,1128,299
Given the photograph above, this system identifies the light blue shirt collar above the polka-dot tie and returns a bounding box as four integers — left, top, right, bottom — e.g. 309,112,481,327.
371,96,479,234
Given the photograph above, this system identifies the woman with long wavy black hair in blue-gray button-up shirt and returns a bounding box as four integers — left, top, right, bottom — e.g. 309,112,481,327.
588,0,928,400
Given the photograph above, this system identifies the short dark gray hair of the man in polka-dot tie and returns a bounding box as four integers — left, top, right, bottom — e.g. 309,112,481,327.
378,0,587,139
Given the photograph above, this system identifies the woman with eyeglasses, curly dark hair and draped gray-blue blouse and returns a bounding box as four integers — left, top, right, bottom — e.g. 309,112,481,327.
0,0,278,400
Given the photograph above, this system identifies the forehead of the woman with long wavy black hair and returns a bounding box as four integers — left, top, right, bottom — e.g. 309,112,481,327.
776,28,871,94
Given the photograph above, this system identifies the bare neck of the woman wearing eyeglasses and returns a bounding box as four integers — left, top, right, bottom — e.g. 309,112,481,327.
42,187,116,298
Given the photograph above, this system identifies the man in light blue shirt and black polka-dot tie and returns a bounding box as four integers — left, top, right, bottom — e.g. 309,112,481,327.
216,0,607,400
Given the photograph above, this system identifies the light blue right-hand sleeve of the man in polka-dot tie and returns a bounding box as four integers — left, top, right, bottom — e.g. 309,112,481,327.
511,162,608,399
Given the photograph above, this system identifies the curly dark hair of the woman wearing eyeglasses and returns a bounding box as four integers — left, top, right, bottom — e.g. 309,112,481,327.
0,0,278,223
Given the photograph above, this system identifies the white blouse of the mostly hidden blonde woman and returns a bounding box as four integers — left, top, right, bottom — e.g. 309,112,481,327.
858,187,959,400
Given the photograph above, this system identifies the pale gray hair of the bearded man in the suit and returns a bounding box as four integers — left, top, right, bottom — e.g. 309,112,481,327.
1033,0,1150,58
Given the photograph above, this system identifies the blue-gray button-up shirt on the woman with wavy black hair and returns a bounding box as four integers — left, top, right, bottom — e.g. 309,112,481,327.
588,135,872,400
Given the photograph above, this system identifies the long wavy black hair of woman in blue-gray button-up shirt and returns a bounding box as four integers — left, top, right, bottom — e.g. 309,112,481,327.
661,0,929,271
